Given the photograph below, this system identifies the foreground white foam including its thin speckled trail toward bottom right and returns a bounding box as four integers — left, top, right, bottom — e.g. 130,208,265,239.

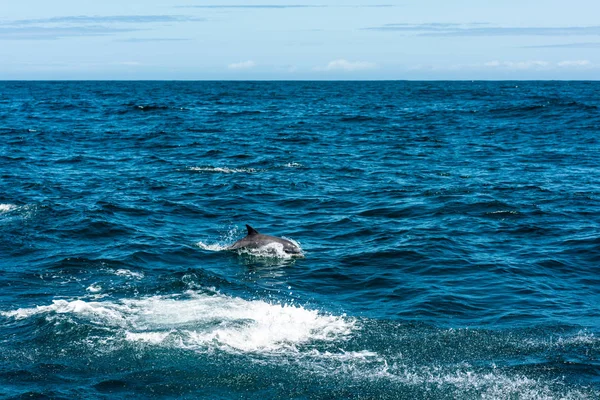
0,291,593,400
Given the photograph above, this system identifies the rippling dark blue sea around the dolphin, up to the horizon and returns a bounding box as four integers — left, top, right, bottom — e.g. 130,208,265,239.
0,82,600,399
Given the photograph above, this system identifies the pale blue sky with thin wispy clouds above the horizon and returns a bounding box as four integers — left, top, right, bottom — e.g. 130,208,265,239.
0,0,600,80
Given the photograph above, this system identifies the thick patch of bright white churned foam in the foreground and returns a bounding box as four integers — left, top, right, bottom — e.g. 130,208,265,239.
1,292,355,353
